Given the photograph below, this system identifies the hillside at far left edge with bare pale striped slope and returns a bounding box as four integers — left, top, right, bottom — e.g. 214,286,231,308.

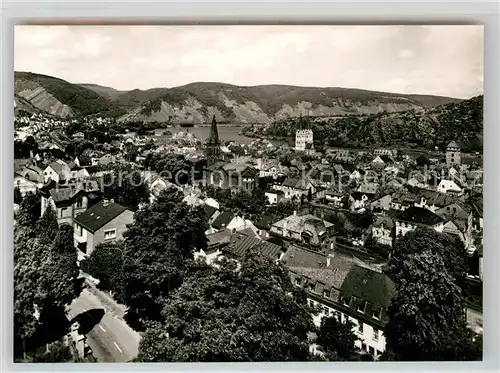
14,71,124,118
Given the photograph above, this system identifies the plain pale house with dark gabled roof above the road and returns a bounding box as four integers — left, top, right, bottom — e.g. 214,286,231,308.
74,200,134,256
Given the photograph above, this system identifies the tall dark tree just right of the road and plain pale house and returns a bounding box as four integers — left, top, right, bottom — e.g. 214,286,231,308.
123,188,208,328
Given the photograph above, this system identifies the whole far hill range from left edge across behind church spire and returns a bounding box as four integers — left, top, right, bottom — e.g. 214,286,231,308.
15,72,460,124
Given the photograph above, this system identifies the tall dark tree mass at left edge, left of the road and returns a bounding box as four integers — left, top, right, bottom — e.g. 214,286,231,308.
14,221,81,355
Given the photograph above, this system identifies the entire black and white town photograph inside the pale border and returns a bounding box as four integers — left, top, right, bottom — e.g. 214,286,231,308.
11,22,482,366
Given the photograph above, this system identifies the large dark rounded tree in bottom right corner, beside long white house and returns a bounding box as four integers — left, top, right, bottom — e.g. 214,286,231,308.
385,229,480,361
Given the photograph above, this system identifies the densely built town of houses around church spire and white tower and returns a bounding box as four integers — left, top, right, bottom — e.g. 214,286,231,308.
14,105,483,361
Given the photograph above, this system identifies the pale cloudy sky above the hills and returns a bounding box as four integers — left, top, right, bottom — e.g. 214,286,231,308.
14,25,484,98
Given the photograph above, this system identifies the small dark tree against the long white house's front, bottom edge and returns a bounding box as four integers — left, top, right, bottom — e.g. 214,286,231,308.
316,316,359,361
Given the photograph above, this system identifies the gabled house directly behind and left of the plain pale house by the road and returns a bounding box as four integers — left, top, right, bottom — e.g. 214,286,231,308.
40,180,101,225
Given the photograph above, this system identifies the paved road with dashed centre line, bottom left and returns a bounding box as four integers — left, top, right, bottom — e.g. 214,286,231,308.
68,287,140,362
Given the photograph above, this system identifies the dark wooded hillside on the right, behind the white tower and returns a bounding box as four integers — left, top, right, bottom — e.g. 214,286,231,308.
264,95,483,151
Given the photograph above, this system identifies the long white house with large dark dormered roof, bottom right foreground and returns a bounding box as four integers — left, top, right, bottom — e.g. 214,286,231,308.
281,246,396,359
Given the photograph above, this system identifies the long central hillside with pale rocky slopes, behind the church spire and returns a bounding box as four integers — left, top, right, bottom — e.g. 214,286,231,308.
119,83,460,124
